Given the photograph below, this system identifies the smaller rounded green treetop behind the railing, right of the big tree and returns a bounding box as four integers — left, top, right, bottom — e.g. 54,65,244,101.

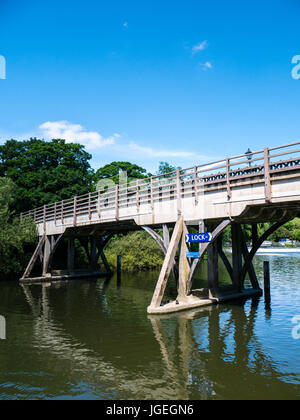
96,162,151,184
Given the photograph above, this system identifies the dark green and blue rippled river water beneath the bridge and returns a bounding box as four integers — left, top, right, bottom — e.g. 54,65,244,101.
0,255,300,400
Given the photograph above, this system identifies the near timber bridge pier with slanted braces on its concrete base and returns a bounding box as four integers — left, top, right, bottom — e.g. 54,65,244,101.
147,217,262,314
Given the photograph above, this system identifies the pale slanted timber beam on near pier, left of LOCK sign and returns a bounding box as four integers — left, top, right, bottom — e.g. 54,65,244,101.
150,216,183,308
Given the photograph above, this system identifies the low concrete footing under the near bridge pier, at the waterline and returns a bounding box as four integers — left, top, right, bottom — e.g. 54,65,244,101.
147,289,263,315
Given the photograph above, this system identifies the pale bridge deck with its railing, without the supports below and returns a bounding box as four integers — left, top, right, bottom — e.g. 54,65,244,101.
21,142,300,236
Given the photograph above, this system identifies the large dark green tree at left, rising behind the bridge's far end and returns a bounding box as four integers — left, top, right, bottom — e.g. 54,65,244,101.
0,138,94,212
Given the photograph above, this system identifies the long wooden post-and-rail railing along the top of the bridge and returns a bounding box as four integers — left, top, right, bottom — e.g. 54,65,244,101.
20,142,300,225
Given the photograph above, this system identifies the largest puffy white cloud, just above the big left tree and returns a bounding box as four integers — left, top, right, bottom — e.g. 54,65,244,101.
39,121,120,149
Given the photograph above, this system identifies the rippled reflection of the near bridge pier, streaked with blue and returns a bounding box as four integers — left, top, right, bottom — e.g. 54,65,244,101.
149,299,293,399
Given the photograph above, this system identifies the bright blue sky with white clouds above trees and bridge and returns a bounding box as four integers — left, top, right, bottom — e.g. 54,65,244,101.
0,0,300,171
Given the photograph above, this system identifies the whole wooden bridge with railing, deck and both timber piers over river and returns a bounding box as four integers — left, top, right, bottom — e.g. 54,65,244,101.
21,142,300,314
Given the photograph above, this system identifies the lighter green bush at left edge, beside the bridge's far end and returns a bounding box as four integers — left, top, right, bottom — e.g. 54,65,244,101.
0,178,37,280
